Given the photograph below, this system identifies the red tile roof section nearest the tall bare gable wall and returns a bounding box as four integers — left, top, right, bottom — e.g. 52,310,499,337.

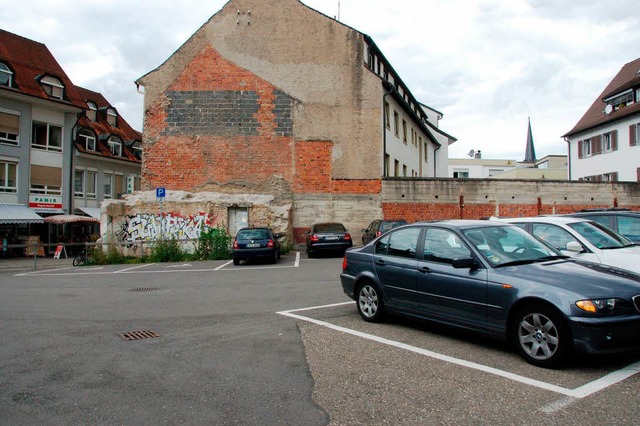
76,86,142,163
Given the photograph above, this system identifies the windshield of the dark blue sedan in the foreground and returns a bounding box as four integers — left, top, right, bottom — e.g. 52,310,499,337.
462,226,566,267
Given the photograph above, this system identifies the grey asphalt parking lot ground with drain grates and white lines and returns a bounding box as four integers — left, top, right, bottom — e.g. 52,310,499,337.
0,254,640,425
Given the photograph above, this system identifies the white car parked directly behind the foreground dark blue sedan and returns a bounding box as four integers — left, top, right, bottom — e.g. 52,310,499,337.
497,216,640,273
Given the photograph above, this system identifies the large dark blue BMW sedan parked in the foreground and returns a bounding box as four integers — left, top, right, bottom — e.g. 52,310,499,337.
340,220,640,367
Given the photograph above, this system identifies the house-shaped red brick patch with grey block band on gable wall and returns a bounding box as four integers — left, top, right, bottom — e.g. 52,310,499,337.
143,46,294,192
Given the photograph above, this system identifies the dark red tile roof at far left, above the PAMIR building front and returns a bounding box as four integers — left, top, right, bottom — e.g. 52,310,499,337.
0,30,87,108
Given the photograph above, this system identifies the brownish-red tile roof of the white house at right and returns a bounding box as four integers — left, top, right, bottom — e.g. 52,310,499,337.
564,58,640,137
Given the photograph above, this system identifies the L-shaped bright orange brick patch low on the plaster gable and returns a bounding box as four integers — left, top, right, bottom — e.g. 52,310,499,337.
293,141,382,194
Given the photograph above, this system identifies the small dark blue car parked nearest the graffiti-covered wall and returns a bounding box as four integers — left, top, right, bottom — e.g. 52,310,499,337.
231,227,284,265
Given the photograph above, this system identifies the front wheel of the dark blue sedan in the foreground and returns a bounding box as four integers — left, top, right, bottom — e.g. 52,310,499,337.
511,304,573,368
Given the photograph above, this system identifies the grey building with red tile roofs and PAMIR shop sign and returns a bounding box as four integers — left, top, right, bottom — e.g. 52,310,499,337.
0,30,141,250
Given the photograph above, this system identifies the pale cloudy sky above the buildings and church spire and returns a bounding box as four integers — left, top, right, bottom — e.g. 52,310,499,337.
0,0,640,160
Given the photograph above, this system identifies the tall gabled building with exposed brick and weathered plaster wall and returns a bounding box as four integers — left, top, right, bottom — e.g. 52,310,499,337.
137,0,455,241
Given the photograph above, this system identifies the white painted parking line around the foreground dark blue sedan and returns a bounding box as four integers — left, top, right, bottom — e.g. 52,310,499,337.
276,302,640,400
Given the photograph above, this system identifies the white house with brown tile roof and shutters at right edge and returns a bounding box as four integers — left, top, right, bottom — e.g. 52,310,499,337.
564,58,640,182
